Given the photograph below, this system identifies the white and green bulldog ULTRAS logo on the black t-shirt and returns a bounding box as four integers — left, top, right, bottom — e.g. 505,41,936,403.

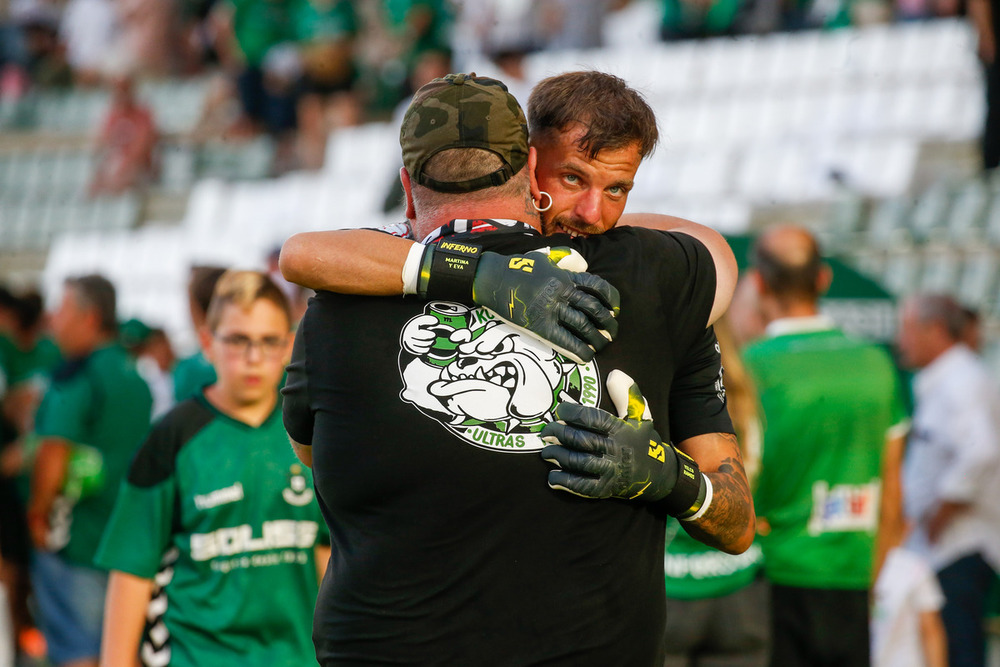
399,301,600,452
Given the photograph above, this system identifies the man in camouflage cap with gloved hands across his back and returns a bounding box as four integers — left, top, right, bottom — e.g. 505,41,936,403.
283,74,753,665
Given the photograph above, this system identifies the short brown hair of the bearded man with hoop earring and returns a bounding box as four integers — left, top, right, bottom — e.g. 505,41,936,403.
528,72,660,158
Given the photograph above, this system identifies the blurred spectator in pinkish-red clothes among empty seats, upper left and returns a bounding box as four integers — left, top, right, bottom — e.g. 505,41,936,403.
90,73,157,197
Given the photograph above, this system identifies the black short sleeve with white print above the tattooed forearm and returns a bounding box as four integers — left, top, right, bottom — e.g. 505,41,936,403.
669,327,734,443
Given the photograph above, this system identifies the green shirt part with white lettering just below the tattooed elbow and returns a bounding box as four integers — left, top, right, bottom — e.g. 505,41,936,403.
663,519,762,600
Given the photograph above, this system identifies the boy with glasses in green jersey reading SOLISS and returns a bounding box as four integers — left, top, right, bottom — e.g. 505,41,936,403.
97,271,326,667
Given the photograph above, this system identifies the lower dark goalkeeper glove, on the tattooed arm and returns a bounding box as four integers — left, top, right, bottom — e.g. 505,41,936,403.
539,370,708,518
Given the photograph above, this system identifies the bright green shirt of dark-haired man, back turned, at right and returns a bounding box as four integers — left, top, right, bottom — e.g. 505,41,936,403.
745,319,905,590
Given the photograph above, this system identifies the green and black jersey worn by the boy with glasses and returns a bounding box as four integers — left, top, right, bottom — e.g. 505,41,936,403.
97,395,329,667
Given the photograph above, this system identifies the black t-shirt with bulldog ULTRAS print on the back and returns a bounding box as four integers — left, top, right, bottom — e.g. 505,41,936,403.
284,223,731,666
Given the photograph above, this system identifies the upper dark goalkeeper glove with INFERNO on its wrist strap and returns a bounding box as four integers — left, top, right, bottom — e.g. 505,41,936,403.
416,239,621,363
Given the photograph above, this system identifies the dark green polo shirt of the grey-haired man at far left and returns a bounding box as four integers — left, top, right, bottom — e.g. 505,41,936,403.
35,345,153,566
